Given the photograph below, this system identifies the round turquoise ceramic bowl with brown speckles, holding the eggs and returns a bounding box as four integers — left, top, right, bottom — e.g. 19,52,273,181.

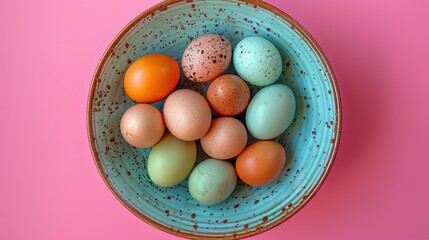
87,0,341,238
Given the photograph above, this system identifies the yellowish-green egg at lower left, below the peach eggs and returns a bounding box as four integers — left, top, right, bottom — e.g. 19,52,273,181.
147,133,197,187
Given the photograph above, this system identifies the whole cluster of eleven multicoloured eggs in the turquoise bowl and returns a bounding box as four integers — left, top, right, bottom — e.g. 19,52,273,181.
120,34,295,205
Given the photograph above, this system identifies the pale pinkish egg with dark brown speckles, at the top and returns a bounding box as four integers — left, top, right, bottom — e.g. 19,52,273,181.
182,34,232,82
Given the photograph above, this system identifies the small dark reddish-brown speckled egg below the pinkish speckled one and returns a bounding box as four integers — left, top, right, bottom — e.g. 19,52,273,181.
207,74,250,116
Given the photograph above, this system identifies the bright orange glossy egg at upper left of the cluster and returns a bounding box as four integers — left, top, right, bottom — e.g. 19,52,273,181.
124,54,180,103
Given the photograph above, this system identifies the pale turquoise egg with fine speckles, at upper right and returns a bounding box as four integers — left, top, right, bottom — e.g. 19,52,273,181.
233,36,283,86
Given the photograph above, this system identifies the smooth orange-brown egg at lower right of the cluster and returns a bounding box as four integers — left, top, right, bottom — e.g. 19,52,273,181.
235,141,286,186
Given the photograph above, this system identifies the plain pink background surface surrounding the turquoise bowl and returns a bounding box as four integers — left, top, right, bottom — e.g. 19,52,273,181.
0,0,429,240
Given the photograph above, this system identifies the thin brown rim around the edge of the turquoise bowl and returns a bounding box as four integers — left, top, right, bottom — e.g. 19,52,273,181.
87,0,342,239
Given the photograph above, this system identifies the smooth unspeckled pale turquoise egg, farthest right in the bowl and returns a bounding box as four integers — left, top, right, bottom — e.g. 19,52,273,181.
246,84,296,139
